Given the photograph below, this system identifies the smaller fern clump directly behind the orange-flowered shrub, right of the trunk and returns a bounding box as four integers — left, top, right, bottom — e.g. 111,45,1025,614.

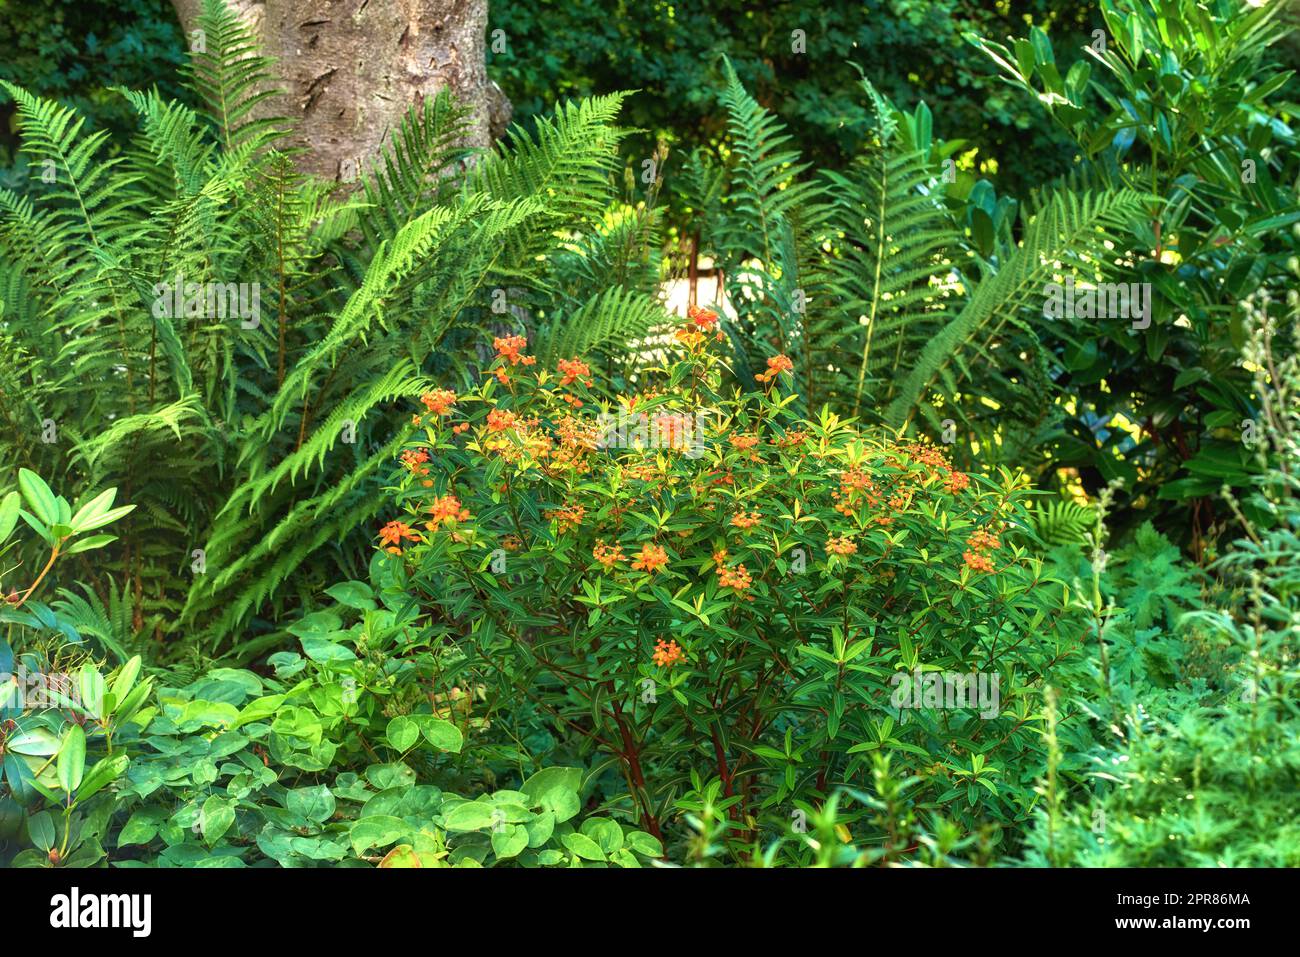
690,62,1143,464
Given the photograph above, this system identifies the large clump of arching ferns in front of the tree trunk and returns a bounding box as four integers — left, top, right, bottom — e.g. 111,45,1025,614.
0,0,663,657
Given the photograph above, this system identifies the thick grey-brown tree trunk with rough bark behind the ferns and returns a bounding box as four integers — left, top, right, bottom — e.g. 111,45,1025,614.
172,0,510,182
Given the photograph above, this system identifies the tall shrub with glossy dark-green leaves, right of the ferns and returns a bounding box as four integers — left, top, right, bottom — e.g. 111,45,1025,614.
976,0,1300,557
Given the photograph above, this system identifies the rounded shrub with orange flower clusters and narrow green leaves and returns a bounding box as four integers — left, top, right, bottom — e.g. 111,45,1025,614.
380,309,1080,854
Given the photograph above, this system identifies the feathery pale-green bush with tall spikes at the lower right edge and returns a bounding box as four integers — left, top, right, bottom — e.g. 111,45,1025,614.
1026,291,1300,867
